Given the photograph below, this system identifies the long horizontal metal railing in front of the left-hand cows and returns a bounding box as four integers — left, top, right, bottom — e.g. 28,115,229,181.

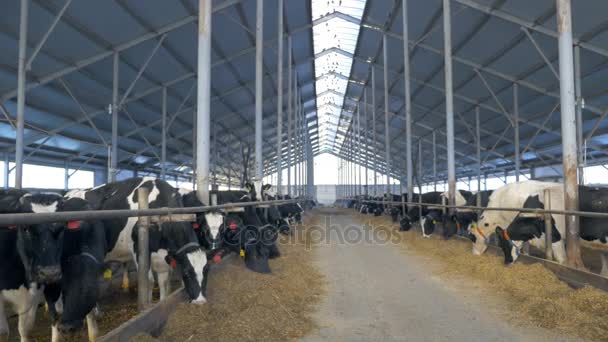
0,199,306,226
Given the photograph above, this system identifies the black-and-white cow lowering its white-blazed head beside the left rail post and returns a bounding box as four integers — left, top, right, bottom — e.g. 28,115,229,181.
66,177,208,304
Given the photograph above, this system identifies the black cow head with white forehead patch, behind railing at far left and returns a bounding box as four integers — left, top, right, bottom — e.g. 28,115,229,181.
16,194,67,284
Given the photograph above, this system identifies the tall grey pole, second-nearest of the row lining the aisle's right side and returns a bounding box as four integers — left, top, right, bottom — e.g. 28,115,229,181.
443,0,456,212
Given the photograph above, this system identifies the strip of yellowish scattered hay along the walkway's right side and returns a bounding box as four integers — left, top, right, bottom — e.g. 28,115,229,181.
357,215,608,341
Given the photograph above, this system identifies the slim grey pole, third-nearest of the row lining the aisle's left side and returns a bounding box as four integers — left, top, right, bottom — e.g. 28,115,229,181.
277,0,284,195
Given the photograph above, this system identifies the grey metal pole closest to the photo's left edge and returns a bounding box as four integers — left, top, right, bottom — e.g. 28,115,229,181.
15,0,29,189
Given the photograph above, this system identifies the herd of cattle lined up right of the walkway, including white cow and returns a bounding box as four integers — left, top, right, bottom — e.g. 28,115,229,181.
341,181,608,276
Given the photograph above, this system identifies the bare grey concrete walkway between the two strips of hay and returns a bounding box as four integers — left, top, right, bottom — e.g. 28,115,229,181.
304,209,572,341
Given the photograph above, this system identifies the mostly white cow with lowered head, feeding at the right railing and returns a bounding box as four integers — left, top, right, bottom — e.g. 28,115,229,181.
467,181,565,262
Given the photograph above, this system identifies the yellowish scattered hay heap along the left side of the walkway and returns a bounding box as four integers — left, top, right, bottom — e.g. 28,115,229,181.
134,218,324,341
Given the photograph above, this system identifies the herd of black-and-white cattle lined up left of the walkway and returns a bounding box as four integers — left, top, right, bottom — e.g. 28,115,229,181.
0,178,314,341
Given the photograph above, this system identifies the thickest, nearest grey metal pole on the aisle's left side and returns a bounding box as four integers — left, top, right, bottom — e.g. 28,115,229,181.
196,0,212,205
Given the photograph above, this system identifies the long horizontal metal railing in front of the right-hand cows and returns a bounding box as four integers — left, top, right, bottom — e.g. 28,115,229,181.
340,198,608,218
